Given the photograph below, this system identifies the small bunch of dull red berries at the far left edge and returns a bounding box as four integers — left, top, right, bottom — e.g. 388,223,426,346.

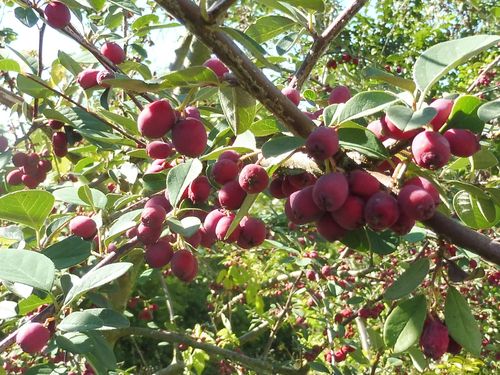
6,152,52,189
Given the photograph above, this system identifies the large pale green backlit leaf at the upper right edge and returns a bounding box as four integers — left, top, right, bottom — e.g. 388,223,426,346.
413,35,500,93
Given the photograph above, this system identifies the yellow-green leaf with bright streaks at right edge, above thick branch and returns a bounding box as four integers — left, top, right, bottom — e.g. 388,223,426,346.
453,190,500,229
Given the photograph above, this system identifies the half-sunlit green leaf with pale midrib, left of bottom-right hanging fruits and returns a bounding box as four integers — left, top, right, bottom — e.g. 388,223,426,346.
384,295,427,353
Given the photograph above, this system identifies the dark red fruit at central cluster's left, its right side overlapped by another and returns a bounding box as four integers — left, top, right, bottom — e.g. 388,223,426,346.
285,186,323,224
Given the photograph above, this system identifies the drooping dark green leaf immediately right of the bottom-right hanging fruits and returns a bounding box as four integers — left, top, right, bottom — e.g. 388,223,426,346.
444,286,482,356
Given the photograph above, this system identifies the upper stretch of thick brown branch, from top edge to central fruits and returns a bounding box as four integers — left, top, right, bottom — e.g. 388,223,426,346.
156,0,315,137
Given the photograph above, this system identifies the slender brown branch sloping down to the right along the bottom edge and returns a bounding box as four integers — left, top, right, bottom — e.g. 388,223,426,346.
118,327,308,375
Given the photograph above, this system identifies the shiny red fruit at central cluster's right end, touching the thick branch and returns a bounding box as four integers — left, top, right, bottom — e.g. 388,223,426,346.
398,185,436,220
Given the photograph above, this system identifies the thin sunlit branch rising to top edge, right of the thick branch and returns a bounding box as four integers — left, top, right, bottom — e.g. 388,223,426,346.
290,0,368,90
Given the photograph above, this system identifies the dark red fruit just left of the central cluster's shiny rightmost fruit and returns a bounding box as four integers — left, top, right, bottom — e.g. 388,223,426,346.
365,191,399,231
